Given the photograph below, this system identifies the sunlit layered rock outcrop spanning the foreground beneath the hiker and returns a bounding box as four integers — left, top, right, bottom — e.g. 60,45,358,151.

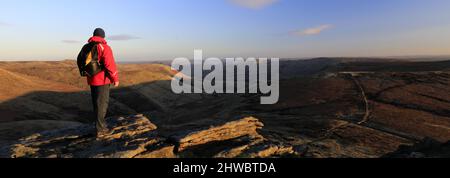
1,115,296,158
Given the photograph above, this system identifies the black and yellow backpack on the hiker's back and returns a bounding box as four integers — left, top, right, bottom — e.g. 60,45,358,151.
77,42,104,77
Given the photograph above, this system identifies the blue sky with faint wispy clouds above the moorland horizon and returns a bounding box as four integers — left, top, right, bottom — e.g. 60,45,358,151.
0,0,450,62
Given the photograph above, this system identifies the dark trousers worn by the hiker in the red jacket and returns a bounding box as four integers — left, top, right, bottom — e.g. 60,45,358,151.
91,85,110,131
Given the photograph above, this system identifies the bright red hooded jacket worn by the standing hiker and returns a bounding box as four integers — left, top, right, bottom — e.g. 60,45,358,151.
87,36,119,86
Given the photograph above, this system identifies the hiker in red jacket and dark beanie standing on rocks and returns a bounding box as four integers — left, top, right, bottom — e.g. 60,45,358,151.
77,28,119,137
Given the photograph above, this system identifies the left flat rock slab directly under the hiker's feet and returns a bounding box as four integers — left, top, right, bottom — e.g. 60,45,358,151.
2,115,165,158
